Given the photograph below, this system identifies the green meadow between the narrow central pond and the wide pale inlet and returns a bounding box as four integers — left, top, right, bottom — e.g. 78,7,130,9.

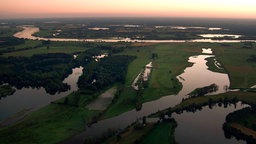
143,43,201,102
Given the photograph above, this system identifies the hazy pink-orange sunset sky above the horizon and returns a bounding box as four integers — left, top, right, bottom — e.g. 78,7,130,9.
0,0,256,19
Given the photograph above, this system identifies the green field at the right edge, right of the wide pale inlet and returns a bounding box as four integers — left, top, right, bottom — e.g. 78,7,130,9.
213,43,256,88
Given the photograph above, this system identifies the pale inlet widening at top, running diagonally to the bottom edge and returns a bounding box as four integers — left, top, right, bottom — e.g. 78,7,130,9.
64,55,236,144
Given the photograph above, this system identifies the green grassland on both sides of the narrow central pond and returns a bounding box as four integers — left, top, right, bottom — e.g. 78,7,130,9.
102,43,201,119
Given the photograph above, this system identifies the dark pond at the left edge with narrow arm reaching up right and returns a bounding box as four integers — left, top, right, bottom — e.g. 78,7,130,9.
0,67,83,121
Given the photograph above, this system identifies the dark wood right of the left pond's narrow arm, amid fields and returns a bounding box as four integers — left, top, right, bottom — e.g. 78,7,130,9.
78,55,135,91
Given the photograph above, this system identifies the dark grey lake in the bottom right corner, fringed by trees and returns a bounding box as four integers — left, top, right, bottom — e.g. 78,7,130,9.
172,102,248,144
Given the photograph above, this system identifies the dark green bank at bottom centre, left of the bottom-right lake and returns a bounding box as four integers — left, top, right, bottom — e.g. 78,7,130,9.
104,120,177,144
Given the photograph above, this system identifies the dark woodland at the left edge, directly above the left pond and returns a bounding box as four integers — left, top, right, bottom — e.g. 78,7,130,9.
0,53,73,94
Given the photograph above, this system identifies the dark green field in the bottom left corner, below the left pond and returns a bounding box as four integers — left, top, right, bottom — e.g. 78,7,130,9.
0,97,99,144
